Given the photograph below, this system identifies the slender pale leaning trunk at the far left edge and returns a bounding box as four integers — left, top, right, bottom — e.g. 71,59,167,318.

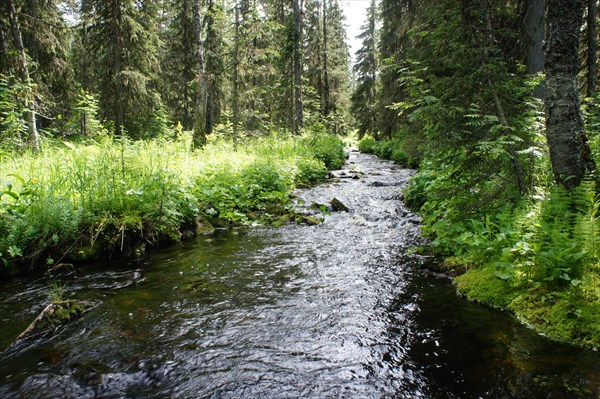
8,0,40,152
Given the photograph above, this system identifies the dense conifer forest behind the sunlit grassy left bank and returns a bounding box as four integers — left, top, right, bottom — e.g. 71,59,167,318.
0,0,350,148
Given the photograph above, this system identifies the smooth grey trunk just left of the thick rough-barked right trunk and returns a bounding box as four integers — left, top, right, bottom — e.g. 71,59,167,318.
525,0,544,98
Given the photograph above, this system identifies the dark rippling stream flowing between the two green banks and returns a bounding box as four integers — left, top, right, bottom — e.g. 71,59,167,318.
0,153,600,399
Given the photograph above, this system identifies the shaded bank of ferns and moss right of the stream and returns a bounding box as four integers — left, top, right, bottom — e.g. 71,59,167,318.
359,138,600,349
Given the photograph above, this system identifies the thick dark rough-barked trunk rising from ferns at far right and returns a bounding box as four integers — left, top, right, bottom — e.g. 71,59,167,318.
545,0,594,190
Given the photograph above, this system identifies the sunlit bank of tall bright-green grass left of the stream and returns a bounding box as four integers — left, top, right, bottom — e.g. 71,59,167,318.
0,133,345,275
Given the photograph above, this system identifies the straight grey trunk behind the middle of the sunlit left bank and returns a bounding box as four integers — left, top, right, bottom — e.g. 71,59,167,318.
192,0,208,148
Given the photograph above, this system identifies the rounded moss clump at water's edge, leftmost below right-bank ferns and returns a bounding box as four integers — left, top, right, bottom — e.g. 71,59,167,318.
455,267,518,309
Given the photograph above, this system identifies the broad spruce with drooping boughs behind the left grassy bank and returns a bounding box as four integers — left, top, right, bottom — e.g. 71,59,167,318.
82,0,162,137
